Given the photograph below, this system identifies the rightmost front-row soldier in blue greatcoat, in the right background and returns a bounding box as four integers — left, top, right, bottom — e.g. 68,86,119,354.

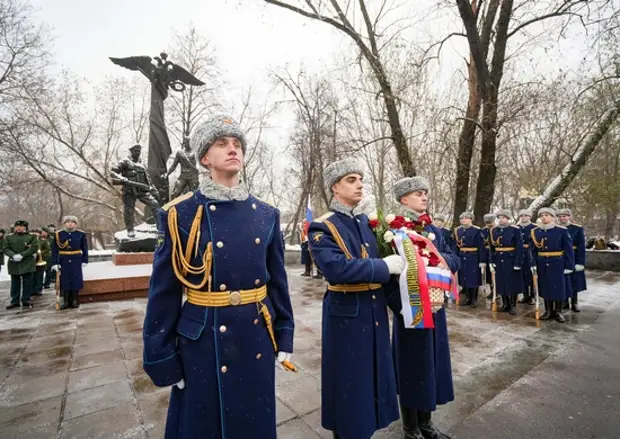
530,207,575,323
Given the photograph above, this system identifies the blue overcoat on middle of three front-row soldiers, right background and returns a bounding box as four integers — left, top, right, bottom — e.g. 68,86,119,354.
489,225,529,296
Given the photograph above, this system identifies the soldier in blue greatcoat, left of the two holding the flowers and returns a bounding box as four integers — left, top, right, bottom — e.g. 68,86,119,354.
309,158,404,439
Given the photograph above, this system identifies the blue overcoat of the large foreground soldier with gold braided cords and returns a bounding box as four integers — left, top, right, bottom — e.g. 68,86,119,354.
143,191,294,439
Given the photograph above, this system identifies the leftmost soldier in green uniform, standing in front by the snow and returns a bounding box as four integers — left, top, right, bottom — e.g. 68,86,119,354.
2,220,39,309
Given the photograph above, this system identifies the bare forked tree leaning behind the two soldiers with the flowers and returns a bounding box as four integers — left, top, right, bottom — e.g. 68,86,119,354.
264,0,416,176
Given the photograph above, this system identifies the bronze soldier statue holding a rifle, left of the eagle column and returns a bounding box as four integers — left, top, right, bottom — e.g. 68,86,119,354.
110,145,159,237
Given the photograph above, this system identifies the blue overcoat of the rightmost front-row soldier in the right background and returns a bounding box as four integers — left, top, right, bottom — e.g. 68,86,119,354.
530,226,575,300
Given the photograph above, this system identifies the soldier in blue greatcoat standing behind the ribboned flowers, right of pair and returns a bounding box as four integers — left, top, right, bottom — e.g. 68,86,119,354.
388,177,459,439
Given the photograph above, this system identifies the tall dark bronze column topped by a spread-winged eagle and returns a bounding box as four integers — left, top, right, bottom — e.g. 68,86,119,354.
110,52,204,204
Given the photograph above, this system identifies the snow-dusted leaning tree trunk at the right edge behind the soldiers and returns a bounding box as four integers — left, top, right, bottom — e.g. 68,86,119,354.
529,101,620,217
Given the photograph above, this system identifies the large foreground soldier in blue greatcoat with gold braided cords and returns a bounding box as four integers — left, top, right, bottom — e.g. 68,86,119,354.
143,116,294,439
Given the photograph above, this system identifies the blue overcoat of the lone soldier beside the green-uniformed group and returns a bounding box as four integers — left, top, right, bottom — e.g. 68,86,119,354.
52,229,88,291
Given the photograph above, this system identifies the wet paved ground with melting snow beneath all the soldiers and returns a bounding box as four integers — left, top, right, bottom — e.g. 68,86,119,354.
0,269,620,439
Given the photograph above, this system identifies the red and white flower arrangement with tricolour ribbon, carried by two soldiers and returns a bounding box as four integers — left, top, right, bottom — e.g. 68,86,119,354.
369,212,458,329
